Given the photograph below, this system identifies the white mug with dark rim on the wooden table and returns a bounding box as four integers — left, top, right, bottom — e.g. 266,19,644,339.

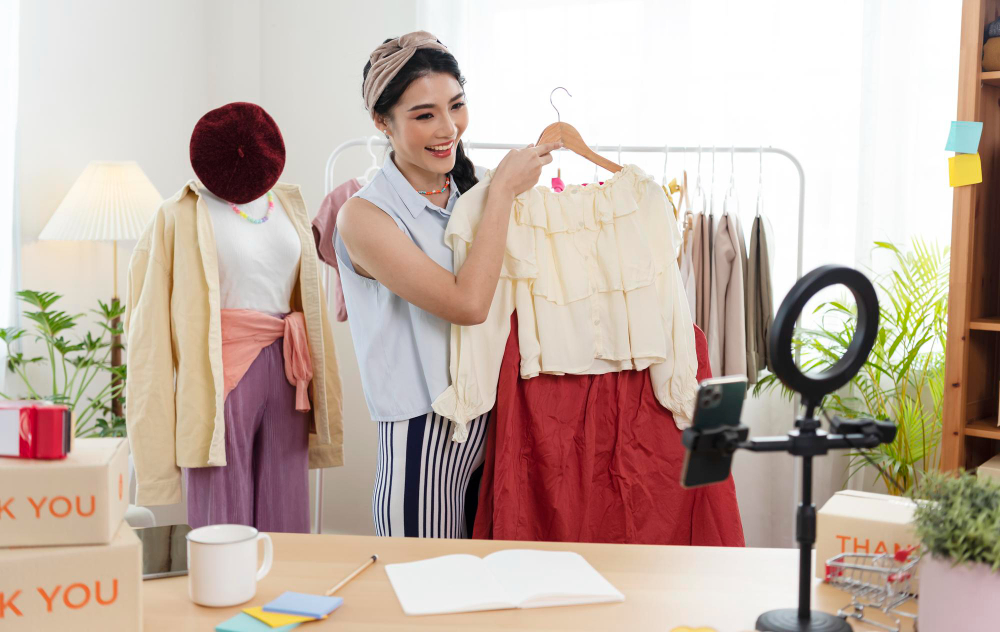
187,524,274,607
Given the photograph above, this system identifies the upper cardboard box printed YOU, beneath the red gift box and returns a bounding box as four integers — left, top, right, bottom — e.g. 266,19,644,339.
0,438,128,547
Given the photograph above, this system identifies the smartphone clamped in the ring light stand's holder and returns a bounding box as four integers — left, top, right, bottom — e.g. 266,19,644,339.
681,375,747,488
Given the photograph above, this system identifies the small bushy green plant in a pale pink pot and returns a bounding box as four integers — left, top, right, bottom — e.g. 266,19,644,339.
911,472,1000,631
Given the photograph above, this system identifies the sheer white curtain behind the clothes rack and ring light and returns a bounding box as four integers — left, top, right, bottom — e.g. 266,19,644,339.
418,0,961,546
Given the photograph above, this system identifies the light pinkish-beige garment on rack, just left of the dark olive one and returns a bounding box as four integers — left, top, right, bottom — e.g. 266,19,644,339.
708,213,747,376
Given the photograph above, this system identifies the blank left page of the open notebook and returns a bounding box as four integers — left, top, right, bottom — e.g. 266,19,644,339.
385,555,516,615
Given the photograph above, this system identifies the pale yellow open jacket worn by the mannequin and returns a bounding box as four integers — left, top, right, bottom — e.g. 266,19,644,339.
125,181,344,505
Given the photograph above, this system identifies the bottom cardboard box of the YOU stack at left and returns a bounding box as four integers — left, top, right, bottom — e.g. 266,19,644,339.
0,522,142,632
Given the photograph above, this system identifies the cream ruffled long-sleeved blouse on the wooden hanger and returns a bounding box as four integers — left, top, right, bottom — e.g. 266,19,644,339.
433,165,698,442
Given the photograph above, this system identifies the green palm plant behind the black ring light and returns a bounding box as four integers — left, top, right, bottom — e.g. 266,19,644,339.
754,239,949,495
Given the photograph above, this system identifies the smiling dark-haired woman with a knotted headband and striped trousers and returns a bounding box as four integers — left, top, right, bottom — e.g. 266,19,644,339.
334,31,561,537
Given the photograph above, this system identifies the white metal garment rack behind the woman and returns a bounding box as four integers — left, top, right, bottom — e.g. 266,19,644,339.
313,136,806,533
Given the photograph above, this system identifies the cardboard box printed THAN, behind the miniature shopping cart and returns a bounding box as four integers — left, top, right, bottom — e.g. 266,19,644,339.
816,490,920,592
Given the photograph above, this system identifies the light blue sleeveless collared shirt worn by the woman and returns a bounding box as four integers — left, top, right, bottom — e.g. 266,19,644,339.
333,155,459,421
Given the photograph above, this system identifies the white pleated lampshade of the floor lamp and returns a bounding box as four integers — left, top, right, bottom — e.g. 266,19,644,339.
38,161,163,241
